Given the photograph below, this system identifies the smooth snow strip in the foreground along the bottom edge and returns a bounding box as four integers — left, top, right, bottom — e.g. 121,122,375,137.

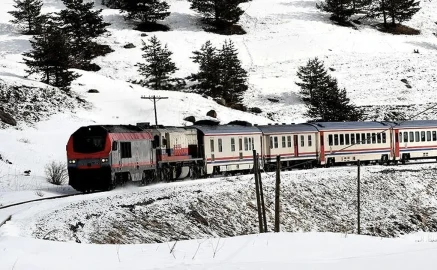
0,233,437,270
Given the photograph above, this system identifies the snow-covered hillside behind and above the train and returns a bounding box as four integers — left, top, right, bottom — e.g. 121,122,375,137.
0,0,437,175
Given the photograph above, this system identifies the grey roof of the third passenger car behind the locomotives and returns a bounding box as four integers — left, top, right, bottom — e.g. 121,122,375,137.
310,121,392,131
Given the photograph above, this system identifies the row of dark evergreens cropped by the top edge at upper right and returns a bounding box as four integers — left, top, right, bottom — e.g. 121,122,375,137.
317,0,420,28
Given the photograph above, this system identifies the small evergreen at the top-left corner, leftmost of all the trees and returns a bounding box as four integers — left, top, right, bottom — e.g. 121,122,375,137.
8,0,42,35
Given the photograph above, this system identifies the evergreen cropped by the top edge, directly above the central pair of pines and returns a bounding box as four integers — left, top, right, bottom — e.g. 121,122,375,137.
189,0,251,25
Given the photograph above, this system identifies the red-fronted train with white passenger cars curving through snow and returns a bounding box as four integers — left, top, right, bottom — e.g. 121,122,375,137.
66,120,437,192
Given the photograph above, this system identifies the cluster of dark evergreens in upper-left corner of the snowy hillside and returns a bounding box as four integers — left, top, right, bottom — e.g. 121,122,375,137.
9,0,111,90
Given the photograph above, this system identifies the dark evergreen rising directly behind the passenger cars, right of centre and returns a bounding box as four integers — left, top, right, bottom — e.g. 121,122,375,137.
296,58,362,121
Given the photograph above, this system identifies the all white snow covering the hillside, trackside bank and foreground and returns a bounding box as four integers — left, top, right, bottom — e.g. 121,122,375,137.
0,0,437,269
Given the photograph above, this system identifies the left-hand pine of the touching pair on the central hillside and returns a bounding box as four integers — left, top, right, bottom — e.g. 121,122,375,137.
189,40,221,98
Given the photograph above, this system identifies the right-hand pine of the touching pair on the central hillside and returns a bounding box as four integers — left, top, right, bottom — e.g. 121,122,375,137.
218,40,248,105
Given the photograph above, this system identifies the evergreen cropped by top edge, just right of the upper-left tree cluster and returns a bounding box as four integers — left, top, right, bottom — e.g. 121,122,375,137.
121,0,170,23
